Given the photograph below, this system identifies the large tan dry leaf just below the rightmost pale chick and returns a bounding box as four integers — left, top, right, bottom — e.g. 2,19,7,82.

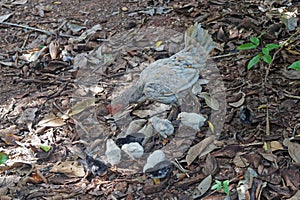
186,136,217,165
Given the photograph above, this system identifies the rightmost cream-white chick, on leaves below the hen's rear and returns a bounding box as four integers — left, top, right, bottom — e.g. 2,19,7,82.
178,112,206,131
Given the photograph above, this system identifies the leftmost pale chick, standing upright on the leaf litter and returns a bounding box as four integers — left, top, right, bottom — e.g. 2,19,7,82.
105,139,121,165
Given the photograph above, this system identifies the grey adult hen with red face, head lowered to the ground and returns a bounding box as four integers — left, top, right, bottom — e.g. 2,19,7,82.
112,23,214,113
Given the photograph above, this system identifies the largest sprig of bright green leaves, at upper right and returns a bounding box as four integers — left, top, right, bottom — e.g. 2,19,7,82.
238,34,280,69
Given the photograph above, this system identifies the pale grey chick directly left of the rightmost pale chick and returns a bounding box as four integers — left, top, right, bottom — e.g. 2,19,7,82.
150,116,174,138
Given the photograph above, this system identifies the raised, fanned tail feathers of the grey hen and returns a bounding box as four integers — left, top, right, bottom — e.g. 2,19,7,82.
184,22,215,56
